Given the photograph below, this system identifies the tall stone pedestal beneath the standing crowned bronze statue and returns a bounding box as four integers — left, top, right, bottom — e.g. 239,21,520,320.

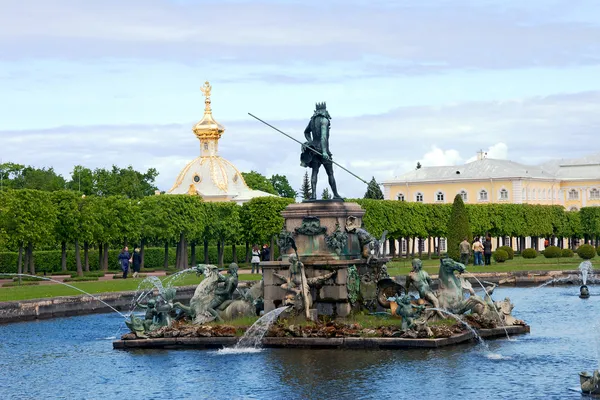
261,201,386,318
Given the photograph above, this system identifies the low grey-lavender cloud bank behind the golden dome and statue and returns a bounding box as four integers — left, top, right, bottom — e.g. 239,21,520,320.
0,92,600,197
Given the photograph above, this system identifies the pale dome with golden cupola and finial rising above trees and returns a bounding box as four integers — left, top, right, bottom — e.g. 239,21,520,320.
167,82,272,204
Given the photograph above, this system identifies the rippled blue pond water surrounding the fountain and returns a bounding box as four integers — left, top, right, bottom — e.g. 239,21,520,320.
0,286,600,400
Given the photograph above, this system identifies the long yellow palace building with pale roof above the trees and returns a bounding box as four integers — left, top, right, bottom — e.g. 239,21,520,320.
383,152,600,255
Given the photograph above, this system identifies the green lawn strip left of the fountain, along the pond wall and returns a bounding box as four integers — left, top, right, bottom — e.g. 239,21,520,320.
0,273,262,301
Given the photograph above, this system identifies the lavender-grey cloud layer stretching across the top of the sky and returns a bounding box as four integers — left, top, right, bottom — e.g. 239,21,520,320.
0,0,600,72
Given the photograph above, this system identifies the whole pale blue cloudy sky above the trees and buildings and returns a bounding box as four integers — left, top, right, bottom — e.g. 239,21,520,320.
0,0,600,197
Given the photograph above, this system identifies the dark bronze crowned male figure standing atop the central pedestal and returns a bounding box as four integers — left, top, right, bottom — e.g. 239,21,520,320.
300,103,342,200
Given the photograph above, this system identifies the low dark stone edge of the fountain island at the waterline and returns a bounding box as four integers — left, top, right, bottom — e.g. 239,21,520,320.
113,325,530,350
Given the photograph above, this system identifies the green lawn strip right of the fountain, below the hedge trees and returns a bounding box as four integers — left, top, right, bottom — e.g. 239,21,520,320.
387,256,582,276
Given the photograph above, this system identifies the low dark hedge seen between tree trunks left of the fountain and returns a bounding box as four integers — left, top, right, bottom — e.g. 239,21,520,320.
0,245,268,275
